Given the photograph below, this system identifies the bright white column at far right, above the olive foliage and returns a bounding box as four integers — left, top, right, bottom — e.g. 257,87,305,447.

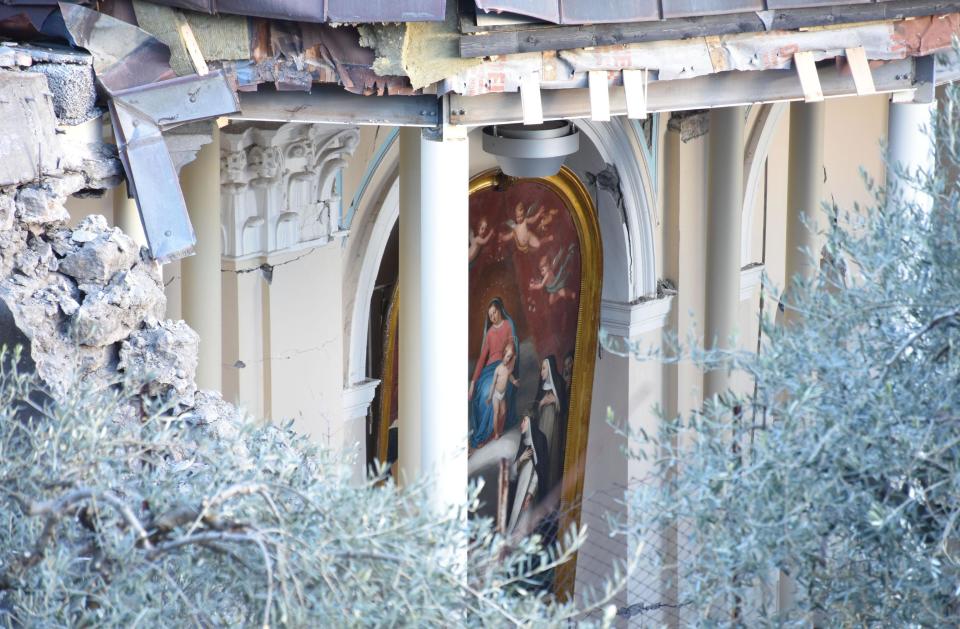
887,100,937,208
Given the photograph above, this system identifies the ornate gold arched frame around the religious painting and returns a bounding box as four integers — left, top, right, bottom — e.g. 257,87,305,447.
377,166,603,598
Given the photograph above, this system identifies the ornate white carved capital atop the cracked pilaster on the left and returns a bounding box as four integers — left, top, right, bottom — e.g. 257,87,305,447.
220,123,360,258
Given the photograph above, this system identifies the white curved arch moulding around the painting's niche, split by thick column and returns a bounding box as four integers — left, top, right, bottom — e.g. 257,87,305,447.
343,118,658,472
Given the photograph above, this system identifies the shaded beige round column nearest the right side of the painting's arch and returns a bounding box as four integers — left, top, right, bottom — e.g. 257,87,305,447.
703,107,745,398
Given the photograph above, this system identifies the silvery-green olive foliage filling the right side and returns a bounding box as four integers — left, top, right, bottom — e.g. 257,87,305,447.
630,87,960,627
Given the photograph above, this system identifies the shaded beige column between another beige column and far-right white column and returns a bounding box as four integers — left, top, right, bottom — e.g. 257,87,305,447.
785,102,826,320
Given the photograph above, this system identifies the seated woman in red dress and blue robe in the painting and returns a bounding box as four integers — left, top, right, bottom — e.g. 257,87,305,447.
469,297,520,448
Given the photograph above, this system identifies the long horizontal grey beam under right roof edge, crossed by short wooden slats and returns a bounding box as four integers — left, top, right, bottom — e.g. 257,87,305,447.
450,58,916,125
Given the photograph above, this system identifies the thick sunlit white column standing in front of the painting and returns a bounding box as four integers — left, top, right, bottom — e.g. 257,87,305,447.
398,129,469,511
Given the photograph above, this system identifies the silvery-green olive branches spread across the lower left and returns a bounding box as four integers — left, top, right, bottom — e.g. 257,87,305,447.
0,356,612,627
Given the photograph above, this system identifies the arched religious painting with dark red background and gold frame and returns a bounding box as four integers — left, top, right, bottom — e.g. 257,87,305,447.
377,168,602,594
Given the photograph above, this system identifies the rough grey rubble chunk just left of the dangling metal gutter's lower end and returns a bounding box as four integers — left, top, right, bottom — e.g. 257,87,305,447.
60,215,140,284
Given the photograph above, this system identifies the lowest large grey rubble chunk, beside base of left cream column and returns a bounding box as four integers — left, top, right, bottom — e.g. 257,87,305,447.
118,319,200,405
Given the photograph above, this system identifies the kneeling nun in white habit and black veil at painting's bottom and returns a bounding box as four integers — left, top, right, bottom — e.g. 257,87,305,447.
505,411,549,537
